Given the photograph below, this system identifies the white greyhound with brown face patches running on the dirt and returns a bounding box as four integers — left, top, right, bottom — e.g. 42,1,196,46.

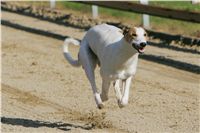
63,24,147,109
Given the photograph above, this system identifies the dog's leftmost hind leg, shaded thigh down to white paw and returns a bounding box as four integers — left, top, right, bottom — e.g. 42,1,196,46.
79,44,103,109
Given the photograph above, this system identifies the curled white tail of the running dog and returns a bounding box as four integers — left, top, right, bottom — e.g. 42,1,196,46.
63,38,81,67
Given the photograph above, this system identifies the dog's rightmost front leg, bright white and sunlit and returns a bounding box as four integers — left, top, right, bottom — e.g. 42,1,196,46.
118,77,132,107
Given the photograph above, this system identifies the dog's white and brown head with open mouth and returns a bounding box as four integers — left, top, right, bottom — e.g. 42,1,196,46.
123,27,147,53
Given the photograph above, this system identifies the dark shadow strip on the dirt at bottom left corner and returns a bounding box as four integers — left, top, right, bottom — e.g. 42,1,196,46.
1,117,93,131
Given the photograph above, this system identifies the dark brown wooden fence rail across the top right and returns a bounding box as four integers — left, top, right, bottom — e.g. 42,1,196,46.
79,1,200,23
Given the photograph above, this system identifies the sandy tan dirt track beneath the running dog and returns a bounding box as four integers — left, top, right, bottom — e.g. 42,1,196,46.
1,12,200,133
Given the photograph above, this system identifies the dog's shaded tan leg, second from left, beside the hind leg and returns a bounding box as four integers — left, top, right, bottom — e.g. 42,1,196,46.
101,79,110,102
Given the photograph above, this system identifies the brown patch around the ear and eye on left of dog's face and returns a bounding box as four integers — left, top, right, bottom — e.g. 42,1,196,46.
123,28,137,42
